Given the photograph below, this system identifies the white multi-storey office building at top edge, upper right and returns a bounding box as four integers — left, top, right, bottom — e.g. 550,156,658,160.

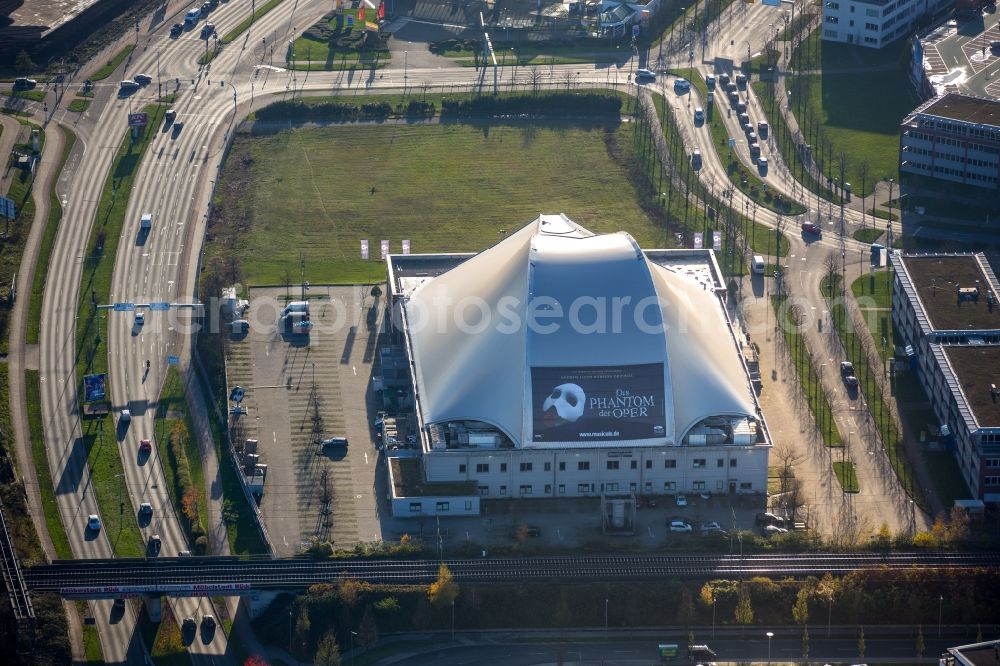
822,0,952,48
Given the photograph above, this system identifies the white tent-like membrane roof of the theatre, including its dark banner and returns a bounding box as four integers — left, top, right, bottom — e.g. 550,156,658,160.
404,215,756,447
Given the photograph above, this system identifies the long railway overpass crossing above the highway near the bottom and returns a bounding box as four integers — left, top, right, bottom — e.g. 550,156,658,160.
24,551,1000,599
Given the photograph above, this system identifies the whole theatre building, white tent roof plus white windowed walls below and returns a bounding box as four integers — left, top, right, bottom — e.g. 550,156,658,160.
388,215,770,508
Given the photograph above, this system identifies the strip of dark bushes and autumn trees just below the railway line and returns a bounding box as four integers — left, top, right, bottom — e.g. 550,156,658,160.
246,566,1000,663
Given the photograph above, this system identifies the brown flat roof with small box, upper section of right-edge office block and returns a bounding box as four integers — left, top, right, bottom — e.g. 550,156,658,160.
903,255,1000,331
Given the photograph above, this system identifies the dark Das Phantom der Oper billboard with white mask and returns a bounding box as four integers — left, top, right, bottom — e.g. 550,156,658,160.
531,363,666,443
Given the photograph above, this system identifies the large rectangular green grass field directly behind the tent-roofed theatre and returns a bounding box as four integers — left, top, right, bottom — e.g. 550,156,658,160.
218,121,667,284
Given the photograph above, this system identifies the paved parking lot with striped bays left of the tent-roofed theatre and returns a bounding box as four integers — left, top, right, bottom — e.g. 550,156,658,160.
226,286,382,555
